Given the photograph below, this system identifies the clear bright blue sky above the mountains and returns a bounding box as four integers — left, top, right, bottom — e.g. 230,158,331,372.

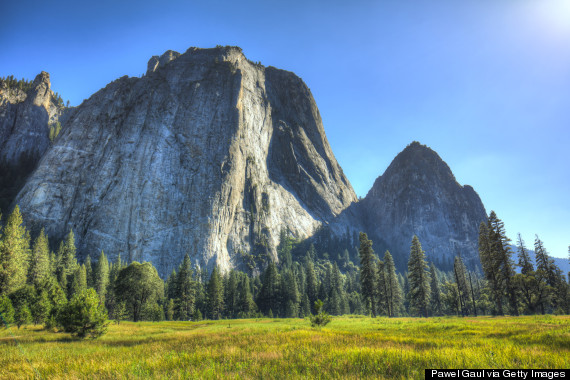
0,0,570,257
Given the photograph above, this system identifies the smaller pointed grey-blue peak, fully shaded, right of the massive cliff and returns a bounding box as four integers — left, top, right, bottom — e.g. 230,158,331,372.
357,142,487,270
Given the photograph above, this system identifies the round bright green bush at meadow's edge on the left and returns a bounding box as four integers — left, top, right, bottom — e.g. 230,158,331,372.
57,288,109,338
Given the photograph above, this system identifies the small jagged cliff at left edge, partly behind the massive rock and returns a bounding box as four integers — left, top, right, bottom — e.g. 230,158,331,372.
0,72,65,212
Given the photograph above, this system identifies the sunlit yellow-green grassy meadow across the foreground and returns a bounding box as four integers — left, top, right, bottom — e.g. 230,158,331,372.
0,316,570,379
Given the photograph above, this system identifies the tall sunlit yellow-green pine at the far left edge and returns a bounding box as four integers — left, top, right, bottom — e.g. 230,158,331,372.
0,205,30,295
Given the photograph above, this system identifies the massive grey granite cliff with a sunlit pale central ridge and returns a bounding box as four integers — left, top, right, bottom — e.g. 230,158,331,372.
16,47,356,275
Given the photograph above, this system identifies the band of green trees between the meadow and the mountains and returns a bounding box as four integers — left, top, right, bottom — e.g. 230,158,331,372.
0,206,570,335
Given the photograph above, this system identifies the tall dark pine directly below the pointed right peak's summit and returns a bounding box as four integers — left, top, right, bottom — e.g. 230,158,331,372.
408,235,431,318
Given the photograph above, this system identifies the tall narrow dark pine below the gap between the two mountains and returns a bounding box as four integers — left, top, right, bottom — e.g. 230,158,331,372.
358,232,377,317
